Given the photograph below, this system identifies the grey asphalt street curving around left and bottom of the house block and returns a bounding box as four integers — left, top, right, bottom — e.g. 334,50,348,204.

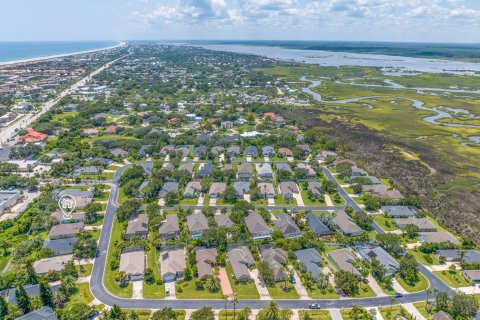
90,162,451,309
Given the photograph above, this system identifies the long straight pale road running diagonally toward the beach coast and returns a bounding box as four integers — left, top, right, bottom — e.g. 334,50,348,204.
0,57,123,145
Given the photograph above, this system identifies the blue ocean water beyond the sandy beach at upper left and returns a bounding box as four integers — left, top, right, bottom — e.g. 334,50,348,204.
0,41,118,62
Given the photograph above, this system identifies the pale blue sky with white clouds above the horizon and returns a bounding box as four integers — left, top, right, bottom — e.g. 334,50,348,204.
0,0,480,42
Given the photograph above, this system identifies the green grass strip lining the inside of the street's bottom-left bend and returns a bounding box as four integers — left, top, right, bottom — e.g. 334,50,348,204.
103,218,133,298
